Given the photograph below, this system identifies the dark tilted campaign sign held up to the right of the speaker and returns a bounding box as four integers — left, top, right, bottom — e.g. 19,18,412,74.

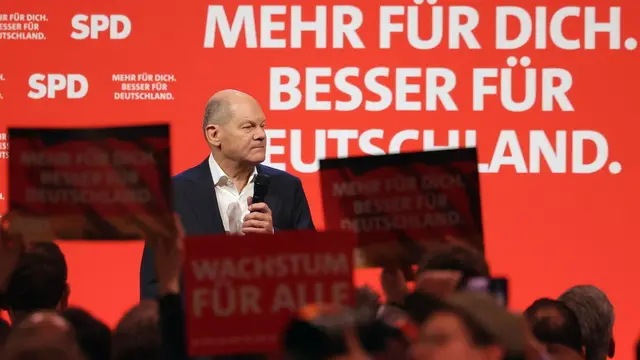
320,148,483,268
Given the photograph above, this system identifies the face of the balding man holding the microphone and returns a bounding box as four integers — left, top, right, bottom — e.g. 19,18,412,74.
216,99,267,165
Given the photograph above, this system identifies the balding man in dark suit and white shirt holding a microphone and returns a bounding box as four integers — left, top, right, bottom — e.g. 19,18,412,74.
140,90,314,299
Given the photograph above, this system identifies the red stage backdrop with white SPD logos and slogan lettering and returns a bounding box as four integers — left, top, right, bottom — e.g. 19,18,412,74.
0,0,640,359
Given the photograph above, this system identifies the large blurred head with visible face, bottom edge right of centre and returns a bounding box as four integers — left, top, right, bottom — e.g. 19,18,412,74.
413,292,525,360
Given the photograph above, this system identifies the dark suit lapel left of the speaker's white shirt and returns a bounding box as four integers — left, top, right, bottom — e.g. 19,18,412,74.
189,158,224,234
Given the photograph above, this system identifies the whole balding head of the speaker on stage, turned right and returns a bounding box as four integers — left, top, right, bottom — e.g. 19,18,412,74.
202,90,267,166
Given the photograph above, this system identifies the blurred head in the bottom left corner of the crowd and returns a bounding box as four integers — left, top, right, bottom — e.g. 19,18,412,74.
0,312,85,360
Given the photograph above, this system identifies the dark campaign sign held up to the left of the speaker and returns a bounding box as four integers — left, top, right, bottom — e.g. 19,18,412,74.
9,125,174,240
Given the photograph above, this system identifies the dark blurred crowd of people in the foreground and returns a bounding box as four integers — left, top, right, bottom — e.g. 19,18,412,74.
0,214,632,360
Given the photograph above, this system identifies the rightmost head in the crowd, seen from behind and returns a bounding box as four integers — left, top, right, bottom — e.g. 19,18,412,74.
558,285,615,360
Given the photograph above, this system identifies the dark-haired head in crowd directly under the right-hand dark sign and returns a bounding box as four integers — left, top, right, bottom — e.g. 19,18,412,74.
416,240,490,297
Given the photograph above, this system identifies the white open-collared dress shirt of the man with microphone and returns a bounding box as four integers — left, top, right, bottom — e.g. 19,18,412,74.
209,154,258,234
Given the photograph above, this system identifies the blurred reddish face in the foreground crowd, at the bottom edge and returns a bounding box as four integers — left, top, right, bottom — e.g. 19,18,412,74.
413,312,498,360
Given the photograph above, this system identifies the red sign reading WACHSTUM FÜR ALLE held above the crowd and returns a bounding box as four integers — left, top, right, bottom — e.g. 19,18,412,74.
183,231,356,356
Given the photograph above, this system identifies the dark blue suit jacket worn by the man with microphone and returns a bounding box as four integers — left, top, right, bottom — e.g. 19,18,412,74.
140,158,314,299
